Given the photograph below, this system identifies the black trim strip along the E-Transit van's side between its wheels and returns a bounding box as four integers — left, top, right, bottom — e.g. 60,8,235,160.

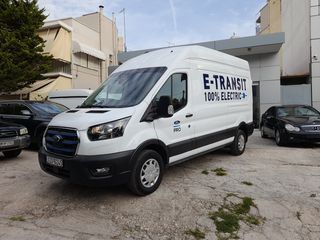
168,127,238,157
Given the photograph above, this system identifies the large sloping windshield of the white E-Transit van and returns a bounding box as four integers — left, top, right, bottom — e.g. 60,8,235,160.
80,67,167,108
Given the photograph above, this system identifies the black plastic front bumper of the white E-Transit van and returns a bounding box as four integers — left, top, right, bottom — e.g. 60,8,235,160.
38,147,134,186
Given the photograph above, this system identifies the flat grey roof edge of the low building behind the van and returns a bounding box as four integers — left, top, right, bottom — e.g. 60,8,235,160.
118,33,285,63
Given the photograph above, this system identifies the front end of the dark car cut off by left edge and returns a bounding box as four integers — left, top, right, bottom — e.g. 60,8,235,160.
0,122,30,158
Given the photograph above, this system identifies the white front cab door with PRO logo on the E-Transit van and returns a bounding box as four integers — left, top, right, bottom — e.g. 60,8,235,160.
154,71,194,163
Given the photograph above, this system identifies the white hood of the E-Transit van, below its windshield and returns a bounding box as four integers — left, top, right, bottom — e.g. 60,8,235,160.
49,107,135,130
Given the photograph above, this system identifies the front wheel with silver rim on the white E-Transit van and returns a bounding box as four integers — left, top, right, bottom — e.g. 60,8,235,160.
128,150,164,196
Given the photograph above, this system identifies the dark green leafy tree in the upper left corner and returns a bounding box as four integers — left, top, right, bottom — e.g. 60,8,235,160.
0,0,52,93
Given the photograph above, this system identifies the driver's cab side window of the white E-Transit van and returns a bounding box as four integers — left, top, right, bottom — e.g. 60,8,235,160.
155,73,188,112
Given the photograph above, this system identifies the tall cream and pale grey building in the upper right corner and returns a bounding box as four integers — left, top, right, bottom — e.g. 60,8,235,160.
256,0,320,110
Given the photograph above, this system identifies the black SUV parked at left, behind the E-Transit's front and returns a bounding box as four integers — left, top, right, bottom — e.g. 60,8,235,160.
0,100,68,146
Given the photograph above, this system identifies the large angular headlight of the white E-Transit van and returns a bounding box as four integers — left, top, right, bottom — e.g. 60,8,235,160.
88,117,130,141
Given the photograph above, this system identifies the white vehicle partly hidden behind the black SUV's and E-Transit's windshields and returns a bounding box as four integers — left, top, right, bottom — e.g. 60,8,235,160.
48,89,93,108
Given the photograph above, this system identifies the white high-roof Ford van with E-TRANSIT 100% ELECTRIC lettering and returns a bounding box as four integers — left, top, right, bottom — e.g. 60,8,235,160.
39,46,253,195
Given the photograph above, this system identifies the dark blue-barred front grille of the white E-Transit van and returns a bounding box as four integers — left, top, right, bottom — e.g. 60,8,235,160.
45,127,79,157
